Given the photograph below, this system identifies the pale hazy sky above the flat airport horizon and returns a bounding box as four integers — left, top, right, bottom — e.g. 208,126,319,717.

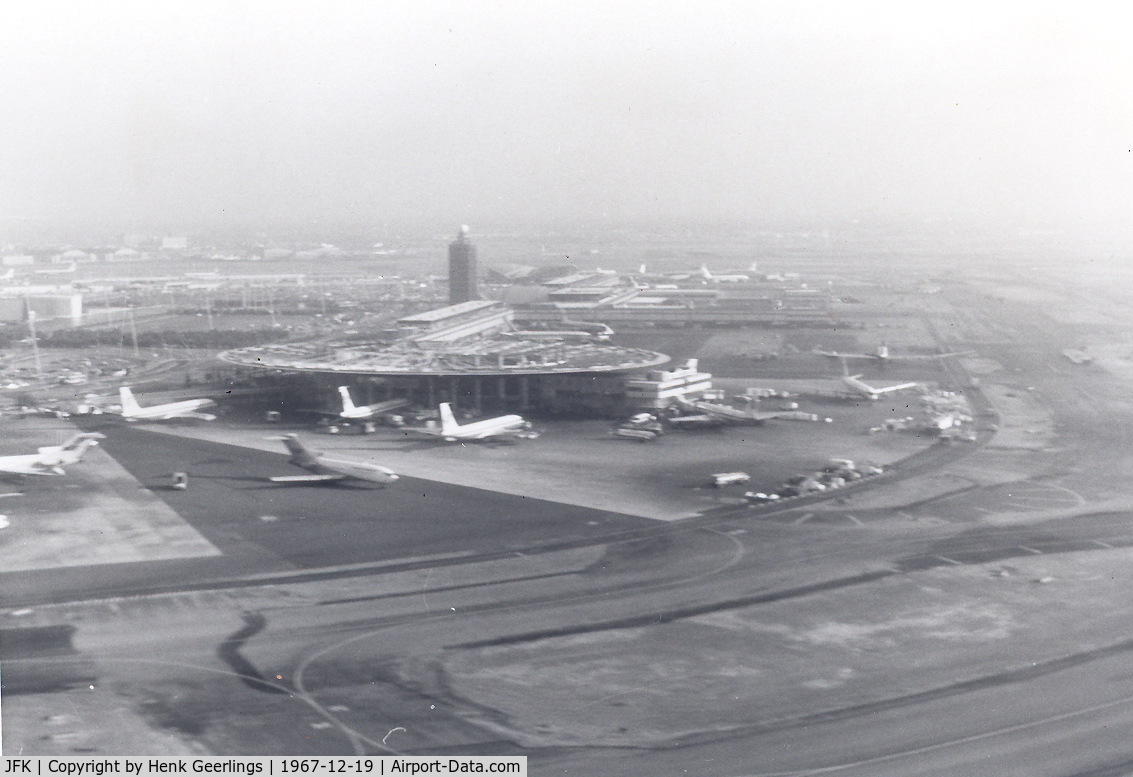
0,0,1133,233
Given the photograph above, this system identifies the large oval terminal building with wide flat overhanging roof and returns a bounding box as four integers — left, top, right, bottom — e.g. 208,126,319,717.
220,299,670,415
